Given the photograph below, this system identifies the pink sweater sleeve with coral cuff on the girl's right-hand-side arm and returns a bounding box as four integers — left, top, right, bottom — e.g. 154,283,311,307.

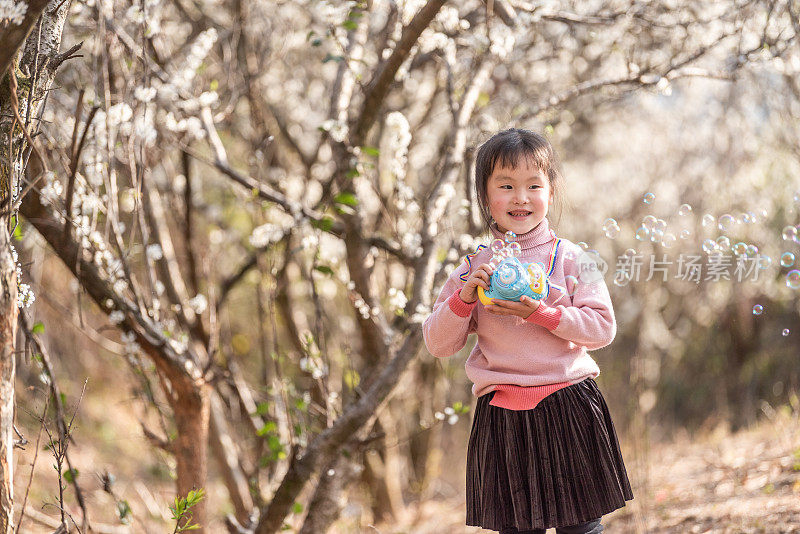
526,247,617,350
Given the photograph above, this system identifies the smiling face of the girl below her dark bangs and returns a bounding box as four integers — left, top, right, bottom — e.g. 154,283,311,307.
486,159,553,234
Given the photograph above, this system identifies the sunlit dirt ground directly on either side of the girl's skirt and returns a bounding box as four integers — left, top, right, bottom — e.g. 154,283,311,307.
364,407,800,534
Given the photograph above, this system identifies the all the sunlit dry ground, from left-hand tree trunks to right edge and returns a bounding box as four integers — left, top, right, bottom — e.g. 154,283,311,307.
15,382,800,534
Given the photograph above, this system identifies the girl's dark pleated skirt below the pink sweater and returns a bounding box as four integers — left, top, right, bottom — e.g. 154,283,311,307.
467,378,633,531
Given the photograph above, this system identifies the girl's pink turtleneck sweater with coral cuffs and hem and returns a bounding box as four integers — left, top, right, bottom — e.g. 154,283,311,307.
422,219,617,410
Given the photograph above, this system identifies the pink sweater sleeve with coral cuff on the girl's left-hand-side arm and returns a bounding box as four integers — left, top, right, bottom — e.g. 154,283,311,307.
422,269,478,358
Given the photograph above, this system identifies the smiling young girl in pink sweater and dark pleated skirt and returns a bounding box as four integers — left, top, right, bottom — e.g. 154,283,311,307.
422,129,633,534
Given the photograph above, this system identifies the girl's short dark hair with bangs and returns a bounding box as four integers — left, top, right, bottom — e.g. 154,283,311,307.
475,128,564,230
